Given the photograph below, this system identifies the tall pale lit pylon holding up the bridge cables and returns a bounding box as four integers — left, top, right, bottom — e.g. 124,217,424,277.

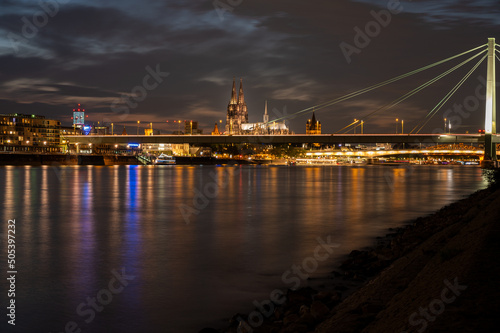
484,38,497,167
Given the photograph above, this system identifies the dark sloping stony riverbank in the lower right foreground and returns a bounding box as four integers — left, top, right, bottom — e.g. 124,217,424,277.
211,172,500,333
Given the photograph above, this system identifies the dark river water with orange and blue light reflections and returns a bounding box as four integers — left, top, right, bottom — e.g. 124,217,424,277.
0,166,486,333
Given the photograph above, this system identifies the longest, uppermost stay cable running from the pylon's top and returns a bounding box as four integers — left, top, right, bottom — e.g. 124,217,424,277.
269,44,486,123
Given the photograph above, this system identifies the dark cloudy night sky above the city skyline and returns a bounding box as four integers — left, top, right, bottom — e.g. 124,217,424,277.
0,0,500,133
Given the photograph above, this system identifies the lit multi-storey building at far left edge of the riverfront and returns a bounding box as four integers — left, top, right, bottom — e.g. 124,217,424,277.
0,113,61,152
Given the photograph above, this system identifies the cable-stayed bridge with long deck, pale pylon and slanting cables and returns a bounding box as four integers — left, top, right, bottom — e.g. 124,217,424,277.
65,38,500,161
